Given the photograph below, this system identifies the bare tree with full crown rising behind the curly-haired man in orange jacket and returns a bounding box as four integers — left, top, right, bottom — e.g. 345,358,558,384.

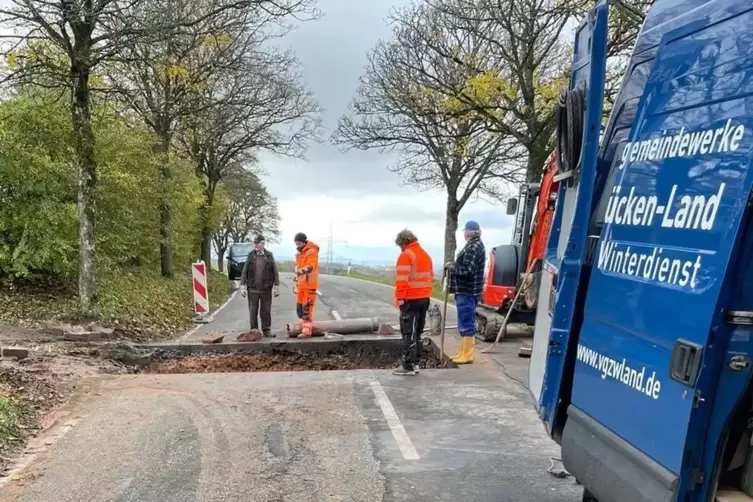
332,1,521,261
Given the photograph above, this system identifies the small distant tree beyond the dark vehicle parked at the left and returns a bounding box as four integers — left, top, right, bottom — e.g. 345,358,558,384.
213,170,280,270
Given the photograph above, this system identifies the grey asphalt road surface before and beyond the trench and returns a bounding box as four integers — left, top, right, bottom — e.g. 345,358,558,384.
0,277,581,502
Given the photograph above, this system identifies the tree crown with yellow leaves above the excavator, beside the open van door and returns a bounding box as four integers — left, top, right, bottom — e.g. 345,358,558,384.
400,0,579,180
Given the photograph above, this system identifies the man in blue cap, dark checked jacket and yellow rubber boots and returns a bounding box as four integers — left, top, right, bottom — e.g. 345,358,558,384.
447,221,486,364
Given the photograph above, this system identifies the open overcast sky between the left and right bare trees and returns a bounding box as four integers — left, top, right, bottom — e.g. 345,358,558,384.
262,0,512,263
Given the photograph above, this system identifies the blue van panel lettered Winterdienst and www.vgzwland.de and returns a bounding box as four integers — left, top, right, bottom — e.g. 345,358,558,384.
562,0,753,502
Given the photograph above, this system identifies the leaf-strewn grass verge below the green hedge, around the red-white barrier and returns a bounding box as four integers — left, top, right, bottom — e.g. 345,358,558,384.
0,270,232,339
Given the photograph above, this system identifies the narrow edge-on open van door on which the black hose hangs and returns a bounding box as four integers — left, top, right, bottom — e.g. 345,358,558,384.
529,2,609,434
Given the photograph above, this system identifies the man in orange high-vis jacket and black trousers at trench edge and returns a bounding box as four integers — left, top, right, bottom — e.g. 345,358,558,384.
393,230,434,375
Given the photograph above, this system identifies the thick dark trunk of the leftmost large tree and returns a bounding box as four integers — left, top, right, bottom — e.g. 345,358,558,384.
71,56,97,314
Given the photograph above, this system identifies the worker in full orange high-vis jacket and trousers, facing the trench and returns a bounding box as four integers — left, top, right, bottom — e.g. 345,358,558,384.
295,232,319,338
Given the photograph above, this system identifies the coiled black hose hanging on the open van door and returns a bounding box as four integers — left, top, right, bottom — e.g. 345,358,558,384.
557,87,586,179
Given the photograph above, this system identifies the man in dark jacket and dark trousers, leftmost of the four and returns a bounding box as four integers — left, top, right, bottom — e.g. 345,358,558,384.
241,235,280,341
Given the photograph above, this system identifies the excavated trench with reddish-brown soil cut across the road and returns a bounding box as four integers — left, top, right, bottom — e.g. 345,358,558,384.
111,340,453,374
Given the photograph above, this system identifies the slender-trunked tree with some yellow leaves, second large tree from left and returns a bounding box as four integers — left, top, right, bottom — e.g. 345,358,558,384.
110,0,317,275
